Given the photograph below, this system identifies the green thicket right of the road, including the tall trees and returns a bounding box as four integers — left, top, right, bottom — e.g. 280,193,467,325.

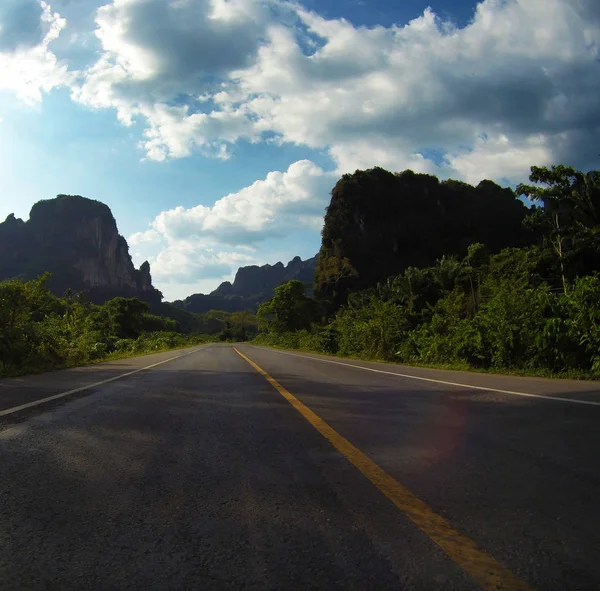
258,166,600,376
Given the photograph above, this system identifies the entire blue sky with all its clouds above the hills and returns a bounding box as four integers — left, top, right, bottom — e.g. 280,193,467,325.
0,0,600,299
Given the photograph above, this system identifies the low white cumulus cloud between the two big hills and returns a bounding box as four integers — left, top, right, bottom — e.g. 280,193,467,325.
128,160,335,284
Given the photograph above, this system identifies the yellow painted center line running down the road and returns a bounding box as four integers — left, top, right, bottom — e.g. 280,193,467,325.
234,347,533,591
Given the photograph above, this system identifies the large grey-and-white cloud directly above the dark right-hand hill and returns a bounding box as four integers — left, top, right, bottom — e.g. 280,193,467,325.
237,0,600,179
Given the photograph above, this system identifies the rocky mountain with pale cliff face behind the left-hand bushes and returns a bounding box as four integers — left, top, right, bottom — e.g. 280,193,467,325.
0,195,161,302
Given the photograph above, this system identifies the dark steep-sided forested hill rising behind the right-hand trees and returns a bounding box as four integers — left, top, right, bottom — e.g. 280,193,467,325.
315,168,532,305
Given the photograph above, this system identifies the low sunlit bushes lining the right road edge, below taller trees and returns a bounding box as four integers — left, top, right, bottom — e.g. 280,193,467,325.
255,260,600,376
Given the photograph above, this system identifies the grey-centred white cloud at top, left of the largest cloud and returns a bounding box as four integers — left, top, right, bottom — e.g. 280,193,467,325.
73,0,268,161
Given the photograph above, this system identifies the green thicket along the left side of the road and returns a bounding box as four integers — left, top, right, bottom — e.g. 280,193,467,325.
0,276,257,376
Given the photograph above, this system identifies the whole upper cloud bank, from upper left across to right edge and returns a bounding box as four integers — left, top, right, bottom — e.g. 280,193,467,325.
62,0,600,180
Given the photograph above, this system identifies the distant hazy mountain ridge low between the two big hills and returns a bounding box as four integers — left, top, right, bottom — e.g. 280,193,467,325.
173,256,317,314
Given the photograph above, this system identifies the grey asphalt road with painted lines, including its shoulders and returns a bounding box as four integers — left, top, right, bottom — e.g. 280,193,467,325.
0,345,600,591
